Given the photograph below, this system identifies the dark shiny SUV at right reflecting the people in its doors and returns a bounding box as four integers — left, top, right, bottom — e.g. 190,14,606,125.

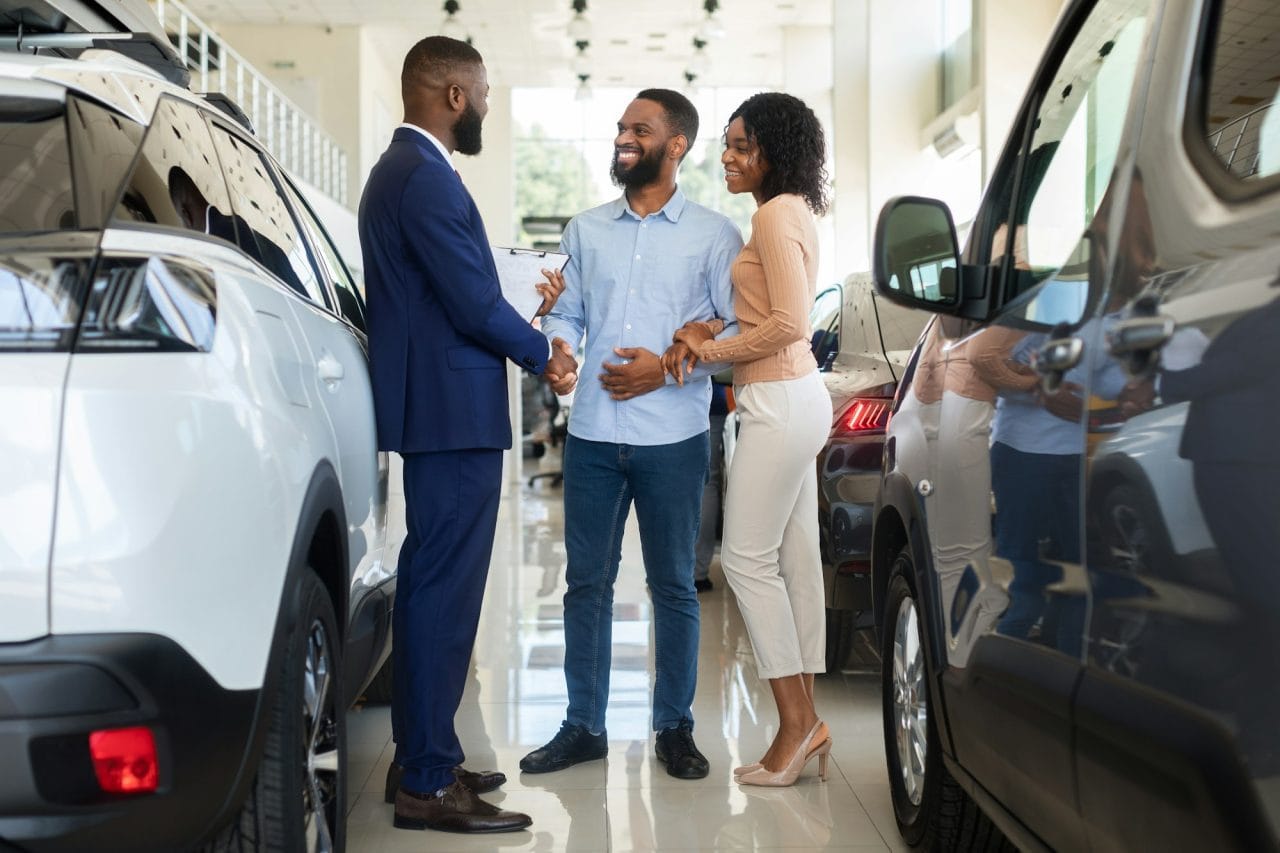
872,0,1280,850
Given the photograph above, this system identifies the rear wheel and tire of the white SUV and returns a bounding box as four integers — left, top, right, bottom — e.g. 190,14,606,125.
206,569,347,853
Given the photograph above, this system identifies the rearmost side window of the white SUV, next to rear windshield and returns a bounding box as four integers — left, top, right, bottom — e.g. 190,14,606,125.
113,97,236,245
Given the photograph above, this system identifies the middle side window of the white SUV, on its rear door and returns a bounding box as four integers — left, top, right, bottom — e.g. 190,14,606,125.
212,124,329,306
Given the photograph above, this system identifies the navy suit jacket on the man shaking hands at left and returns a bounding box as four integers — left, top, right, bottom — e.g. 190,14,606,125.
360,128,548,453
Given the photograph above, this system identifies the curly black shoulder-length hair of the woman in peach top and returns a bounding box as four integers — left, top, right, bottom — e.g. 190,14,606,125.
724,92,828,216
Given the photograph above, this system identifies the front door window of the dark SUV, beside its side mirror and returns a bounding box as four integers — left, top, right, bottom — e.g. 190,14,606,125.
975,0,1149,325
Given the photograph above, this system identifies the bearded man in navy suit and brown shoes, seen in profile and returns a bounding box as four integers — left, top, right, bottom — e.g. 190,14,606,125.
360,36,577,833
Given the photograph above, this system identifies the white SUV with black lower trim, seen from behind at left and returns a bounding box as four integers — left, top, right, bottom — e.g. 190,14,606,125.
0,51,402,850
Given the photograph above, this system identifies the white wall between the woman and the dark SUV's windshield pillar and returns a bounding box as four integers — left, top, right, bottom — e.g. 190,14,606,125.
832,0,1064,278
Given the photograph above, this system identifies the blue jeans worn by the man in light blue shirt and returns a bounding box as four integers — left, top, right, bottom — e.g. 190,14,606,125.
563,433,709,734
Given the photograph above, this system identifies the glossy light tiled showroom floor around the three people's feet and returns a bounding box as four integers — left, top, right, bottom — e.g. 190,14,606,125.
348,448,901,853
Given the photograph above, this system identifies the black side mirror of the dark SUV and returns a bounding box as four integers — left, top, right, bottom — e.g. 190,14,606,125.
872,196,963,314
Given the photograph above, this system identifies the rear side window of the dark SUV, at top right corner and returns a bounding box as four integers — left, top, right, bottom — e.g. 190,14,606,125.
1201,0,1280,181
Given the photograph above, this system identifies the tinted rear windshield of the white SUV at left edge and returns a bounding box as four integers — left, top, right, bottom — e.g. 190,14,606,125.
0,96,79,234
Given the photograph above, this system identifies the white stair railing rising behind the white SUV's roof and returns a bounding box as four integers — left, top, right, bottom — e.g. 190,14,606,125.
150,0,347,205
